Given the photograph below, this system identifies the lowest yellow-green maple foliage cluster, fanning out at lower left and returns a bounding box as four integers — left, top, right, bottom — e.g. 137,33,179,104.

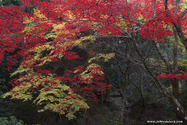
3,69,89,119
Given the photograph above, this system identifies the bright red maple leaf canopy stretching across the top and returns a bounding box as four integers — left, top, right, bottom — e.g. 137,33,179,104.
0,0,187,106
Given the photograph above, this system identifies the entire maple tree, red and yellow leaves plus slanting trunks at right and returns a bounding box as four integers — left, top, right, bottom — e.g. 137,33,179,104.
0,0,187,120
